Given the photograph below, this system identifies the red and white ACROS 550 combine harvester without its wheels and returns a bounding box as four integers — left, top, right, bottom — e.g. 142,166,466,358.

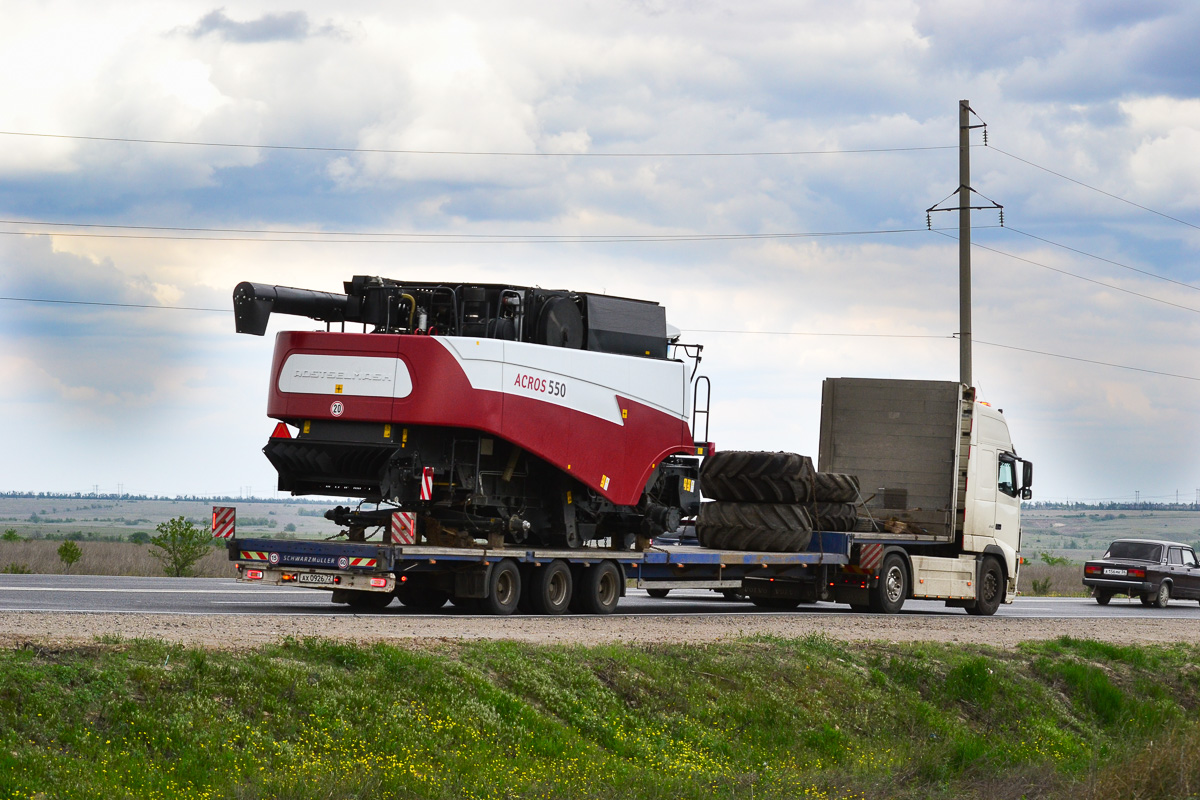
234,276,703,548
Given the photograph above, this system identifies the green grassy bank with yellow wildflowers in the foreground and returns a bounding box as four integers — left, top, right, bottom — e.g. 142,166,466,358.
0,637,1200,800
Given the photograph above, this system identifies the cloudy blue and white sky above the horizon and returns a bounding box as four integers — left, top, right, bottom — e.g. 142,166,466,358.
0,0,1200,501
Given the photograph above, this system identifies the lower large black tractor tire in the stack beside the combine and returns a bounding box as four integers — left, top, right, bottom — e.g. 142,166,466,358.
696,503,812,553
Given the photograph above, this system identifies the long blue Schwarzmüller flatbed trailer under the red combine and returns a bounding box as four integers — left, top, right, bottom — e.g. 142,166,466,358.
227,531,859,614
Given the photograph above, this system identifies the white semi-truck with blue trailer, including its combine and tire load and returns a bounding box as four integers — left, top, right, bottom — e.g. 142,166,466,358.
225,276,1032,615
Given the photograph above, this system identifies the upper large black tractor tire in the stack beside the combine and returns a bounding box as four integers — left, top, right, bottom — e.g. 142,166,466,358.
700,450,817,503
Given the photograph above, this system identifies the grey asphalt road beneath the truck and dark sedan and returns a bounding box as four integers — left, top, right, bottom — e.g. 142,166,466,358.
0,575,1200,620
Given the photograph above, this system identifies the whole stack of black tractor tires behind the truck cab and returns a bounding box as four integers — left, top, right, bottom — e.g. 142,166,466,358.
696,450,859,553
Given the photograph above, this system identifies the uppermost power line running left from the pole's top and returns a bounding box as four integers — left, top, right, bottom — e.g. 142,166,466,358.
0,131,956,158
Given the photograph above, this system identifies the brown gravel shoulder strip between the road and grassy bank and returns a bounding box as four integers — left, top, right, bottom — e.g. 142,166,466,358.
0,612,1200,649
